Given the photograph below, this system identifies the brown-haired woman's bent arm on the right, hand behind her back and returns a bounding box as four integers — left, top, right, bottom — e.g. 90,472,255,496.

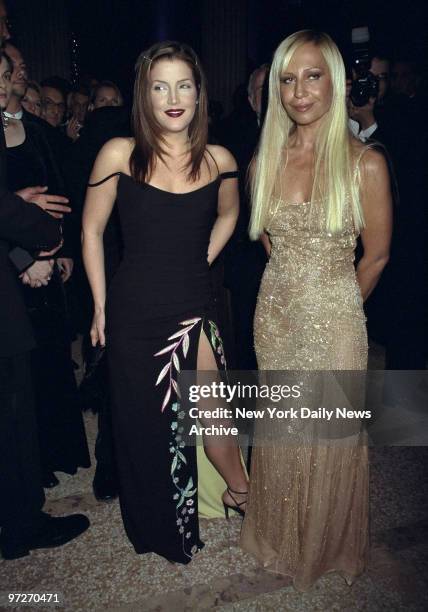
208,146,239,265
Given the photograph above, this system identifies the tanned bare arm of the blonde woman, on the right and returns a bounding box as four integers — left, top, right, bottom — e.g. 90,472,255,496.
357,149,392,301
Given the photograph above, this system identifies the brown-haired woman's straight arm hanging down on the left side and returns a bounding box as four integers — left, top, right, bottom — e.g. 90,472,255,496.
82,138,126,346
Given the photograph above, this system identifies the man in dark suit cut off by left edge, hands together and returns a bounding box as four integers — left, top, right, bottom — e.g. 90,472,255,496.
0,0,89,559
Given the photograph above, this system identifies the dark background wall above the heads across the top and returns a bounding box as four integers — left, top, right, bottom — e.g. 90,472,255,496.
8,0,427,110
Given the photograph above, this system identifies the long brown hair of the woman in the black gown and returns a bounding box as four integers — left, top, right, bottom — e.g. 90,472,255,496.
130,40,208,183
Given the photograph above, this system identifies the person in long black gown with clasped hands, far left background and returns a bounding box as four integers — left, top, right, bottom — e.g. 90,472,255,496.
0,55,90,487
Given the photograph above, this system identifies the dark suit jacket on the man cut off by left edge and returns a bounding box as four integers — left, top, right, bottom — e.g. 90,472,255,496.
0,120,61,358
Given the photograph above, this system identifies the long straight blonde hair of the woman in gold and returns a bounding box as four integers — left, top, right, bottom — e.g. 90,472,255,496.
250,30,364,240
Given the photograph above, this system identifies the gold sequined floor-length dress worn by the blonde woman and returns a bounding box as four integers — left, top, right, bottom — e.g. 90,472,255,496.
241,199,368,590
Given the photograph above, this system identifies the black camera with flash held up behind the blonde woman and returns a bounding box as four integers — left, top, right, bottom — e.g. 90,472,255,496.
349,26,379,106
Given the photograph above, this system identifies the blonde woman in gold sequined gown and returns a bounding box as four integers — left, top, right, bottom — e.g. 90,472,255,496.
241,30,391,590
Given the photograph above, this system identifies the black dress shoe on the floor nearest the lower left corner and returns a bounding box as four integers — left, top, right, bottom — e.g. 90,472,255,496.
0,513,89,559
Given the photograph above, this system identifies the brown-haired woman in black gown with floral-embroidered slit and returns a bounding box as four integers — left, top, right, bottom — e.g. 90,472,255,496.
83,42,247,563
